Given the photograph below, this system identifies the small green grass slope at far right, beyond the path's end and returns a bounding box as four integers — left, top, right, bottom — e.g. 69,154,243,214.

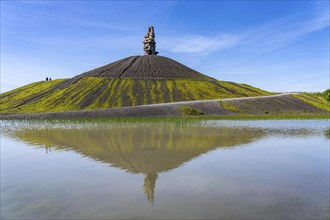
293,93,330,111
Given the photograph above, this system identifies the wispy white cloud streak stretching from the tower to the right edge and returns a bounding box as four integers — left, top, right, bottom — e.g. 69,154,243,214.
159,2,329,55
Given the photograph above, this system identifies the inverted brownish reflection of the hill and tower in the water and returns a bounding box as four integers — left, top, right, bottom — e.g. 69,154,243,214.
3,125,266,203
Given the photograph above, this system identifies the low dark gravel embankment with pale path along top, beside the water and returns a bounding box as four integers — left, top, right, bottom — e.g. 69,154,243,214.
0,93,329,119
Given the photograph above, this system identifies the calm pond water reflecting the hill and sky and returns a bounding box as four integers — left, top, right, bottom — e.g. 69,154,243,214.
1,120,330,219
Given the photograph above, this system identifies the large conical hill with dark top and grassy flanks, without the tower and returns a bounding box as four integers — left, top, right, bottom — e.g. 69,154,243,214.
0,55,269,113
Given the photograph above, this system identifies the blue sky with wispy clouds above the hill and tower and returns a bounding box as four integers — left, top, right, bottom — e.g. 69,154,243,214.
1,0,329,92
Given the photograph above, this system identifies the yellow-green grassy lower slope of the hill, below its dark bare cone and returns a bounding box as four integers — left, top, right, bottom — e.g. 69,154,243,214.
0,77,271,113
